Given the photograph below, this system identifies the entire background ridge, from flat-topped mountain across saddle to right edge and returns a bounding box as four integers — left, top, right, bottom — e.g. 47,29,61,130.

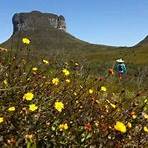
1,11,148,64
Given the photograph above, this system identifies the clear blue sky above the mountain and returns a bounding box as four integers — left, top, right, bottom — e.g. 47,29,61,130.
0,0,148,46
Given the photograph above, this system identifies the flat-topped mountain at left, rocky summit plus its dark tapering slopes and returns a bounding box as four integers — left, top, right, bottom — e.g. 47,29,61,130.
2,11,111,53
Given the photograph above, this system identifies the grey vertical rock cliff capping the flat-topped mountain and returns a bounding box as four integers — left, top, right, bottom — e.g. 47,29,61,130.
12,11,66,33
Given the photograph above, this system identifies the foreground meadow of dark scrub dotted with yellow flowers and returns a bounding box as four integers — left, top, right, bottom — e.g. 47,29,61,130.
0,38,148,148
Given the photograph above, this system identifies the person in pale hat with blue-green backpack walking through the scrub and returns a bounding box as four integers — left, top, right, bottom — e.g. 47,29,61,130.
115,59,127,79
